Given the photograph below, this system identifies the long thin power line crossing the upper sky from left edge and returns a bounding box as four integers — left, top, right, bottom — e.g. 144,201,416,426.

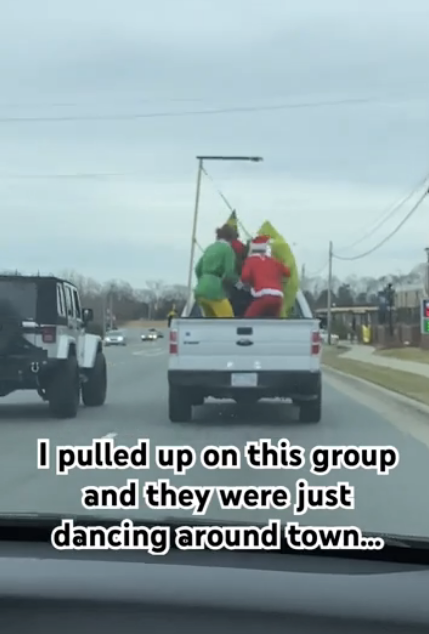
0,99,382,124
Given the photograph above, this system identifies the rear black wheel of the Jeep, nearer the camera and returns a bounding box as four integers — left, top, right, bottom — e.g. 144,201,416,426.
48,357,80,418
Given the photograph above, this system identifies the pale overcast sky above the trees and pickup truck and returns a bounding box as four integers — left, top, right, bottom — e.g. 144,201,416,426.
0,0,429,287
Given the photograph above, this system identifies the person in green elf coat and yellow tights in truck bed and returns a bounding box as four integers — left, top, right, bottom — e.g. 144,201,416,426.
194,225,238,318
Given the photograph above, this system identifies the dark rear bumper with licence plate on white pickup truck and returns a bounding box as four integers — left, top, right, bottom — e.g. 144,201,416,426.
168,370,322,401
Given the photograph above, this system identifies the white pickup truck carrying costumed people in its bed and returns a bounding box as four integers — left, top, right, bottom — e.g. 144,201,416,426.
168,291,322,423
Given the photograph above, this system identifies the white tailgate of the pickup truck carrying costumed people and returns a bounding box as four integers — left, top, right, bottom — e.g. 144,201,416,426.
169,319,320,371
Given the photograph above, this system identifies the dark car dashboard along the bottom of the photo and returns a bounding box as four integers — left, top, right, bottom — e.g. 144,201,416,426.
0,541,429,634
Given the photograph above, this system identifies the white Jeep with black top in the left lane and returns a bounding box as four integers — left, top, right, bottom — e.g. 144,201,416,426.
0,275,107,418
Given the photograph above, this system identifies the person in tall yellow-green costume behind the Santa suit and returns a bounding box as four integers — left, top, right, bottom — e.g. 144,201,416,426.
257,220,299,318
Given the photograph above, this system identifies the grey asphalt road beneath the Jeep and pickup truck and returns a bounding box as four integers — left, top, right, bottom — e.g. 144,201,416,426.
0,326,429,536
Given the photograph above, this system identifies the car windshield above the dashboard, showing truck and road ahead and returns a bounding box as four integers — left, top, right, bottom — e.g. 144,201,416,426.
0,0,429,548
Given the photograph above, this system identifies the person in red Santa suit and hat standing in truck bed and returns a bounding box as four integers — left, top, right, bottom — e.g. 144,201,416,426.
241,236,290,317
